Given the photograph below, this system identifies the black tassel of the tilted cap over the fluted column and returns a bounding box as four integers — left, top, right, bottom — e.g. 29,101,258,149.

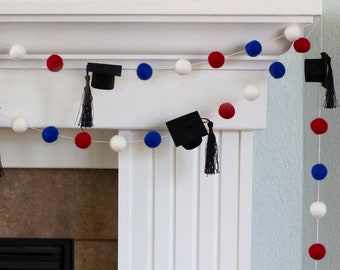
204,121,220,175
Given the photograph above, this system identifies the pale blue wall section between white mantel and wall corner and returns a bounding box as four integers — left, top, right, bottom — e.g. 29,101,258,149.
252,49,303,270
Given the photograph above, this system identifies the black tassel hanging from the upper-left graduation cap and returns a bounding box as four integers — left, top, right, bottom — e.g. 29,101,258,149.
78,74,93,128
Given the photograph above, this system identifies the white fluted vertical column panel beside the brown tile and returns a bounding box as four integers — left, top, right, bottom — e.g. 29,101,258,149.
118,131,252,270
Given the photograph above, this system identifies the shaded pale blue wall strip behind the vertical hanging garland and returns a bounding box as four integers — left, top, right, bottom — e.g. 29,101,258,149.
302,0,340,269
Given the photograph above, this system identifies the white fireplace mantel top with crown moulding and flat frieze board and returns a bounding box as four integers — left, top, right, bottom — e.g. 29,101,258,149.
0,0,321,130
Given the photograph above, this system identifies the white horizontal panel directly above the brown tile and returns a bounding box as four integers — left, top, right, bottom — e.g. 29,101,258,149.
0,127,118,169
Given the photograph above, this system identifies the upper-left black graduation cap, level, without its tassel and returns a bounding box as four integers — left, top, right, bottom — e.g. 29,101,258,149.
86,63,122,90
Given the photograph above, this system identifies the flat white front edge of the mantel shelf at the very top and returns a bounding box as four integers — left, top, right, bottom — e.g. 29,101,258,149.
0,0,322,16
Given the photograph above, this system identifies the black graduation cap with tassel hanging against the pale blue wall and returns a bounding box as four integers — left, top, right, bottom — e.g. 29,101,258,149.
305,52,337,109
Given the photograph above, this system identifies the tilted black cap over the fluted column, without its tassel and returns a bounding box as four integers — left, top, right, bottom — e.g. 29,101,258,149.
166,111,208,150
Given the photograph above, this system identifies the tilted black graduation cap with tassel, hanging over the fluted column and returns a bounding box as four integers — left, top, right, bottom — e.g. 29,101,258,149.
166,111,219,174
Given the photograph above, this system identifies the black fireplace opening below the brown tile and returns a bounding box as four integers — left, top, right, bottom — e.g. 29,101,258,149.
0,238,74,270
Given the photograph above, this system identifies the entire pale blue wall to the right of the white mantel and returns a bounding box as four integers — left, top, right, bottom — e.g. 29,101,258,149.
252,0,340,270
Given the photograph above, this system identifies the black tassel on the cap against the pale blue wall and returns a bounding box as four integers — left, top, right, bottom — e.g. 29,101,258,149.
321,52,337,109
